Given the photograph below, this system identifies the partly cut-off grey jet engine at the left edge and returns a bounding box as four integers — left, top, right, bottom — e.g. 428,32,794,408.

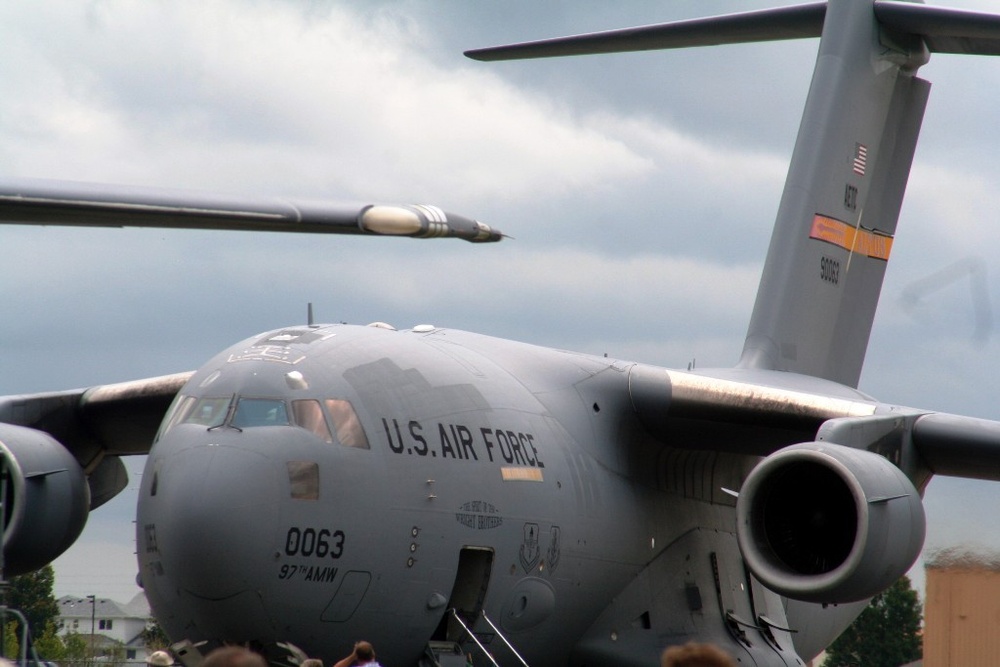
0,424,90,576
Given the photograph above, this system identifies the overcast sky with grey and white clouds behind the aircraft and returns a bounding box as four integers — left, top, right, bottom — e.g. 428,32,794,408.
0,0,1000,601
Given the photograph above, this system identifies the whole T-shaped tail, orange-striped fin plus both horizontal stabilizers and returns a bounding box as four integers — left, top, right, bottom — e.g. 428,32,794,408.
467,0,1000,387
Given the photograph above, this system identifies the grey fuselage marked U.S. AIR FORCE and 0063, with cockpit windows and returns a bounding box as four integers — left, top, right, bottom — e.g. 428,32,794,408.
137,325,852,664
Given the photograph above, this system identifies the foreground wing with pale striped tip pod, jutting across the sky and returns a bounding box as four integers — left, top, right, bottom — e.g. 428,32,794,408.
0,179,503,243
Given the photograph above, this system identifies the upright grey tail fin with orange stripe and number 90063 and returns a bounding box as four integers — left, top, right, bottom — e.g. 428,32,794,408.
740,0,930,386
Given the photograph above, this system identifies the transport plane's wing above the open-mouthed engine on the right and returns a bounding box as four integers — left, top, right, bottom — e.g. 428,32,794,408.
629,365,1000,481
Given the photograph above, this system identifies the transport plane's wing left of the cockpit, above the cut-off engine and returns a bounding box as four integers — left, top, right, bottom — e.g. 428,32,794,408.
0,372,192,509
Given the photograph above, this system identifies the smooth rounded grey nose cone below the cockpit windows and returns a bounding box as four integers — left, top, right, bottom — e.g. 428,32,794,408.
139,432,287,600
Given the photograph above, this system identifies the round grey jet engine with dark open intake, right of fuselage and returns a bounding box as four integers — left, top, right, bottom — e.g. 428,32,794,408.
736,442,925,603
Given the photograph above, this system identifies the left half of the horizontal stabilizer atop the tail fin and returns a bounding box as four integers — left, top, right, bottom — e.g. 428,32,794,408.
465,2,826,60
